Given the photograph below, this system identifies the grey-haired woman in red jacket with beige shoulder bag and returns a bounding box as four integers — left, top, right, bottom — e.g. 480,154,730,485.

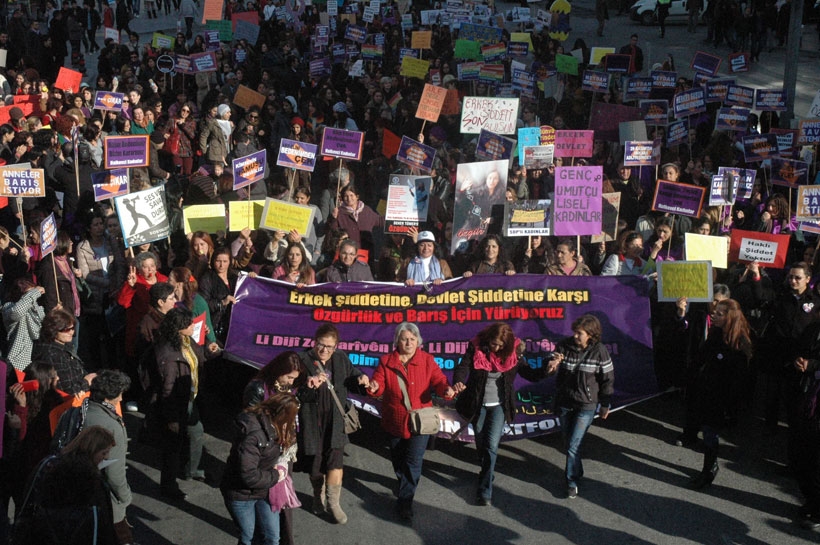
368,322,454,521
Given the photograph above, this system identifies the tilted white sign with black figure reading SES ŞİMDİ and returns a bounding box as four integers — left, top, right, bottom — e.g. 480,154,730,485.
114,185,171,248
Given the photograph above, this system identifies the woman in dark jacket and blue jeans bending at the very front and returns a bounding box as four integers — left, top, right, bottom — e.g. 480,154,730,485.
220,393,299,545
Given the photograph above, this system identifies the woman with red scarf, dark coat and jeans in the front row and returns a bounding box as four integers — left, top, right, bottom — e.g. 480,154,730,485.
453,322,546,505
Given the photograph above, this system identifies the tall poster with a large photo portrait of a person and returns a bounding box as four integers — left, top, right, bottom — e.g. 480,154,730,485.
450,159,510,253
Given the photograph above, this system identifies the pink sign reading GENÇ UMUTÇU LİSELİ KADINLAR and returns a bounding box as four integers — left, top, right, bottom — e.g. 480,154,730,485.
552,165,603,236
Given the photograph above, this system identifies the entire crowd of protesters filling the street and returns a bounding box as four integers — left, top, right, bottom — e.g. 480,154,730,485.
0,0,820,544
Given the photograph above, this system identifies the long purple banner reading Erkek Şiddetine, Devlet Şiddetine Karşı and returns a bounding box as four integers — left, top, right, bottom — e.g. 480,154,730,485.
225,274,658,441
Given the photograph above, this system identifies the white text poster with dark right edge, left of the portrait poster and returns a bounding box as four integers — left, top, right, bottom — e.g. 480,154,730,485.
384,174,433,234
